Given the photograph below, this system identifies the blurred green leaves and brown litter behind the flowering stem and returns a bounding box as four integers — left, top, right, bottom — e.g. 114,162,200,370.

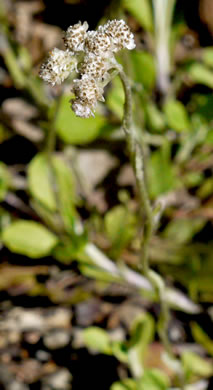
0,0,213,390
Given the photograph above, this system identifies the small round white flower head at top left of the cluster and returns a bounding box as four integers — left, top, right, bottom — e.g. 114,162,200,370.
64,22,88,52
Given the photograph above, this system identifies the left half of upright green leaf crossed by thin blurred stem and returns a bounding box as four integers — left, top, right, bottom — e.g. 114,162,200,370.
28,153,56,211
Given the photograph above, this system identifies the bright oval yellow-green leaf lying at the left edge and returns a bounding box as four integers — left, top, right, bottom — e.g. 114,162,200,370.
2,220,58,258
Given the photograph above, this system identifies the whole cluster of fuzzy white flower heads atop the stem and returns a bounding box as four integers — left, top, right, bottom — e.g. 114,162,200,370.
40,19,135,118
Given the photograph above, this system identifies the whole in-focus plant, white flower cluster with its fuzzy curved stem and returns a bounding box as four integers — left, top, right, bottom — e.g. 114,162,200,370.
40,19,184,389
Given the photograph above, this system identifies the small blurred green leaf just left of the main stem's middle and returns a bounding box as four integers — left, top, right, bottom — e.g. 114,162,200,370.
104,205,136,251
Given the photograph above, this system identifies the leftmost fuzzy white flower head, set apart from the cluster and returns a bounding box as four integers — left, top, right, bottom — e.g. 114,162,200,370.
39,48,77,85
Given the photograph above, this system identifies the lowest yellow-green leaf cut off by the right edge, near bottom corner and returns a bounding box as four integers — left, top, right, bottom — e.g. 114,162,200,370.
182,351,213,377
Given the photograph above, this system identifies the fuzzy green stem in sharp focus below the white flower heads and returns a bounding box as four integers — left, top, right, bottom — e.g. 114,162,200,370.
119,68,185,386
